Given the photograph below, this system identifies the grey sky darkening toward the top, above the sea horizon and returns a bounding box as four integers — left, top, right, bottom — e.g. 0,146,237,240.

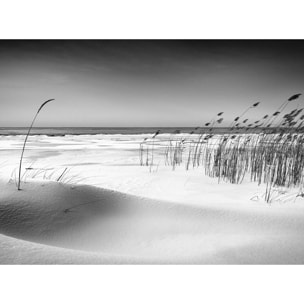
0,40,304,127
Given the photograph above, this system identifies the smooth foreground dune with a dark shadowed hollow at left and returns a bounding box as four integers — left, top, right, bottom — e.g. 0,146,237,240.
0,181,304,264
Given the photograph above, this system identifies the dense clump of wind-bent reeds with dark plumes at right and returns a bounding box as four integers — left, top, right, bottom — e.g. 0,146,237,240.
141,94,304,202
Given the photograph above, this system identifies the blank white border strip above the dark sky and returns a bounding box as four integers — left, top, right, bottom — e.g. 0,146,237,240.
0,0,304,39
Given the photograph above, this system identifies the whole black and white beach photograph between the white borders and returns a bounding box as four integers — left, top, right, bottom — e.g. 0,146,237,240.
0,40,304,264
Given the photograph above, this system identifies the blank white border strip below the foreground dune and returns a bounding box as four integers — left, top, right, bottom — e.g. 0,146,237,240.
0,265,304,304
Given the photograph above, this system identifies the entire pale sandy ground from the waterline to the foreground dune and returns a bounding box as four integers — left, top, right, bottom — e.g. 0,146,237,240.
0,135,304,264
